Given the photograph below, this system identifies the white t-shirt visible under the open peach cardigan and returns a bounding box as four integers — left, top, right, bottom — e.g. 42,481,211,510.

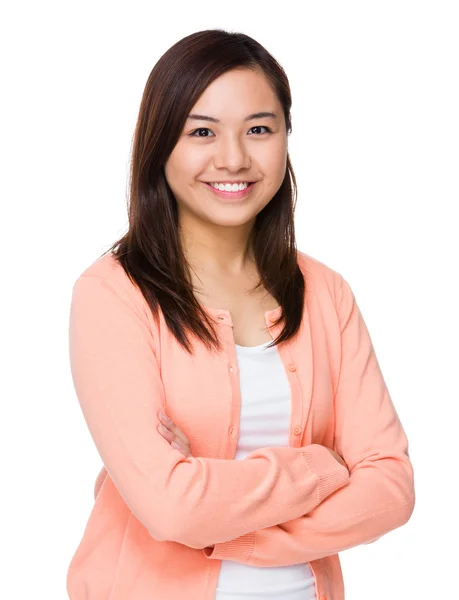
215,341,317,600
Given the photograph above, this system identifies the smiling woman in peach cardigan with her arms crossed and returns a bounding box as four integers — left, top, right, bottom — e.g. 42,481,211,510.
67,29,415,600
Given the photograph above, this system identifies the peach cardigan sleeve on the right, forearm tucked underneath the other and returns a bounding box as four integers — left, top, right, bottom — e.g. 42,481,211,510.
202,278,415,567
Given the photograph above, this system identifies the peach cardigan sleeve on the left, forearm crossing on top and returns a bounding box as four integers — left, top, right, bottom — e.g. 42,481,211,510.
69,275,349,549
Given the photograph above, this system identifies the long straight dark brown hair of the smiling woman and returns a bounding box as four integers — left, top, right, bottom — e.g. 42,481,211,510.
102,29,305,353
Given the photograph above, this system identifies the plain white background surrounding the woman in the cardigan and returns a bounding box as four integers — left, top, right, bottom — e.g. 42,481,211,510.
0,0,459,600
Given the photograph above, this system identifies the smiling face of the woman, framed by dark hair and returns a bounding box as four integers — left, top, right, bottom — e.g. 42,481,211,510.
165,68,287,233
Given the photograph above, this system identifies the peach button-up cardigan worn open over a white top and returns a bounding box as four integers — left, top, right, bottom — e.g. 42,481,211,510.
67,251,415,600
